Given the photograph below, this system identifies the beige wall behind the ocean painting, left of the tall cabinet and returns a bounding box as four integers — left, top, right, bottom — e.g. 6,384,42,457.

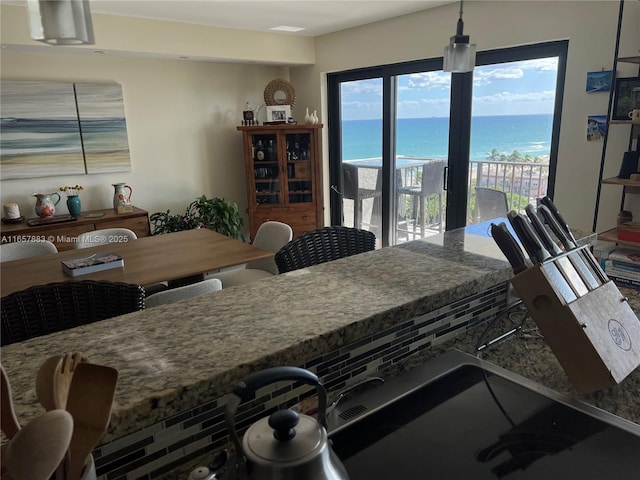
1,51,288,229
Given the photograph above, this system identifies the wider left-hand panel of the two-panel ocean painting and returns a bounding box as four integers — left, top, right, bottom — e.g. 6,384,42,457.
0,81,85,180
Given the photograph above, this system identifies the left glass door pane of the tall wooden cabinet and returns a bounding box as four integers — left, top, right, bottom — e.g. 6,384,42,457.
251,134,280,205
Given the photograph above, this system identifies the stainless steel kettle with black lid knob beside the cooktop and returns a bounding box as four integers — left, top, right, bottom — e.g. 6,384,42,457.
225,367,349,480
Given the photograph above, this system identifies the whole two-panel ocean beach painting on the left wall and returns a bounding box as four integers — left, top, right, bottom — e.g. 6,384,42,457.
0,81,131,180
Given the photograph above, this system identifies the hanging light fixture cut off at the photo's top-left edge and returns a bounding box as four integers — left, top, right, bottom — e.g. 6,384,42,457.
27,0,95,45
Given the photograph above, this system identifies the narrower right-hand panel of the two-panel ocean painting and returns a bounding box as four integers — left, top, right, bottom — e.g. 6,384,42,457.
75,83,131,174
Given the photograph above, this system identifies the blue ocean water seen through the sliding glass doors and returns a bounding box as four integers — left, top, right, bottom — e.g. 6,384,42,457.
342,114,553,160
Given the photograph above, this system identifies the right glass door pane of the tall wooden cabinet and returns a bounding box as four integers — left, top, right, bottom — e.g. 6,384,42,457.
285,133,313,204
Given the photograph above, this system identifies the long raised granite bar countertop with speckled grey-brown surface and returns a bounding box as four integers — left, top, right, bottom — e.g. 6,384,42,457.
2,222,640,450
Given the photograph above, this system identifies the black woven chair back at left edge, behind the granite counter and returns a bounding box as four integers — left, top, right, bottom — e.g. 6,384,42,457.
0,280,145,346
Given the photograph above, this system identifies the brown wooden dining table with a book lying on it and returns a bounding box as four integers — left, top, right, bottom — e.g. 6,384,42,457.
0,228,273,297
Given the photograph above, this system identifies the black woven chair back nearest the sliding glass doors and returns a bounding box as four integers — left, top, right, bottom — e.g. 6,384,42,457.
275,226,376,273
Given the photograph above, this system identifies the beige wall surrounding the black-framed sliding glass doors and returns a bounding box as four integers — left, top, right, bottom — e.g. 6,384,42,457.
290,1,640,229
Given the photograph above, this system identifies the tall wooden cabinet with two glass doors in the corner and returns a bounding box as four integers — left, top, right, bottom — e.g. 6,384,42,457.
238,124,324,238
